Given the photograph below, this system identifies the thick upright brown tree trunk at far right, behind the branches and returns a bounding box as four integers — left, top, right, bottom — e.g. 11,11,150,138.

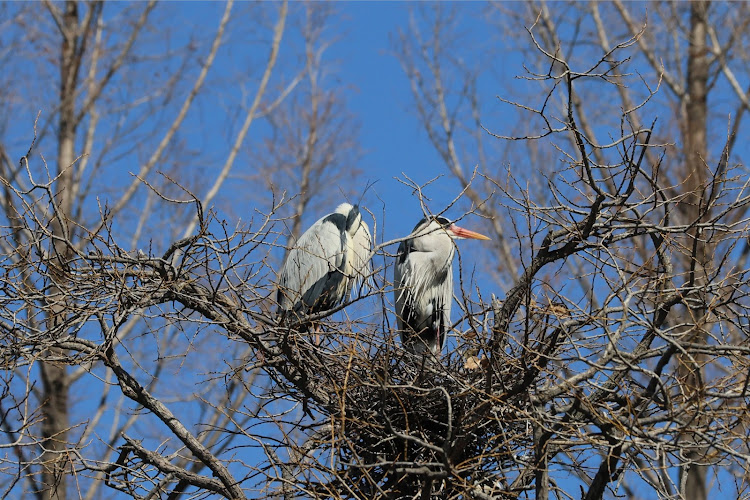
678,1,709,500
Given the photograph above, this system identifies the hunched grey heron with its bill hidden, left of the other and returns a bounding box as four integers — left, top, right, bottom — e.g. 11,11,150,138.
276,203,372,330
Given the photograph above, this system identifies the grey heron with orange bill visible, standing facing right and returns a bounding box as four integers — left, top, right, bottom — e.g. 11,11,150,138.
393,217,489,356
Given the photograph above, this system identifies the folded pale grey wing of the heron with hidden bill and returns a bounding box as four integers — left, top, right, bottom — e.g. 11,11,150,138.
278,218,344,311
